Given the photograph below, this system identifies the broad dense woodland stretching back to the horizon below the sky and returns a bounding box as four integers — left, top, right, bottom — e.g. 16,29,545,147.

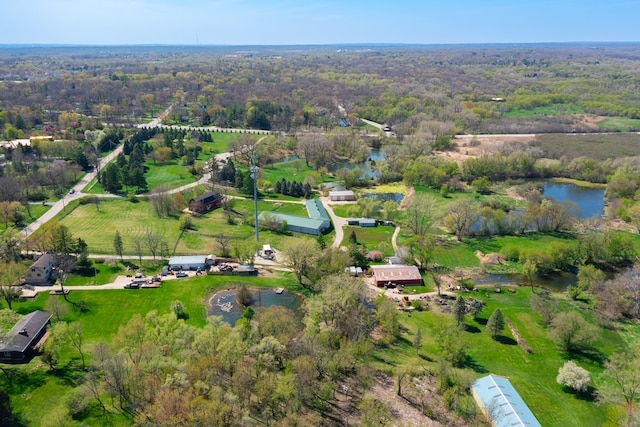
0,44,640,139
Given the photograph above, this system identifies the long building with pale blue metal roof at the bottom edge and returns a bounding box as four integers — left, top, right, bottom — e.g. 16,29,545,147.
471,374,542,427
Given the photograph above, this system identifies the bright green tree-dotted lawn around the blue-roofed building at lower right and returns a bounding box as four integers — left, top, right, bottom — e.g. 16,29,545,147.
374,288,623,426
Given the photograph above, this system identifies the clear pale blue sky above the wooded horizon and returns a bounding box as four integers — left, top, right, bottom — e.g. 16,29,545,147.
0,0,640,45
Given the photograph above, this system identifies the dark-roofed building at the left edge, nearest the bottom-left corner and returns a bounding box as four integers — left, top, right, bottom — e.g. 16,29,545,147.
0,310,51,363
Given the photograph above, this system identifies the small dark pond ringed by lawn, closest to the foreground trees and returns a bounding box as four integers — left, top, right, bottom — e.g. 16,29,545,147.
207,289,302,326
